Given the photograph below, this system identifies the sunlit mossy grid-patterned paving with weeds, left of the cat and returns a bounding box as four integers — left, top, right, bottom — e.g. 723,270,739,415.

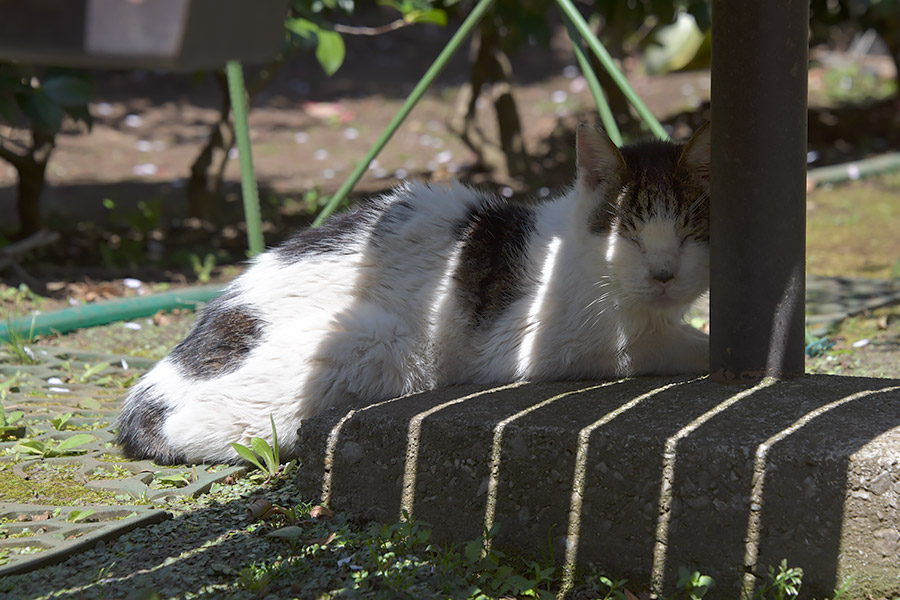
0,348,245,577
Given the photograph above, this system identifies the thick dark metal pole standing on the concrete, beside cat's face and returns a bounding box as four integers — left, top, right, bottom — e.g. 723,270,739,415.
710,0,809,381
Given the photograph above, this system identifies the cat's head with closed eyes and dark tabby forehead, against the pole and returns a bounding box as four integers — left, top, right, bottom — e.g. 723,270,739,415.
576,123,710,309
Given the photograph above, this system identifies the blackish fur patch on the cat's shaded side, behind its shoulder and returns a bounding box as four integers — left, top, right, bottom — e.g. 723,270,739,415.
453,202,535,329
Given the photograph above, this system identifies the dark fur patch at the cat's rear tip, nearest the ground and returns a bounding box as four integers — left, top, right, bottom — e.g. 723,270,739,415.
116,386,184,465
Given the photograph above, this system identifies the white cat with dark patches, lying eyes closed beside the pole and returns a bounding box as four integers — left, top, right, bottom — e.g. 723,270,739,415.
118,123,710,464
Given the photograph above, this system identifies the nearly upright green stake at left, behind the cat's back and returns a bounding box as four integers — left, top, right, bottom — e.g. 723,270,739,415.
225,60,264,256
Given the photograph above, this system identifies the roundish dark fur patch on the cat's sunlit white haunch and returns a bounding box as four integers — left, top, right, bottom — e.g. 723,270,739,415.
169,292,266,379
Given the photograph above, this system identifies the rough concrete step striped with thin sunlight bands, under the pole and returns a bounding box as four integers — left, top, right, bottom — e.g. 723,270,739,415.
298,376,900,598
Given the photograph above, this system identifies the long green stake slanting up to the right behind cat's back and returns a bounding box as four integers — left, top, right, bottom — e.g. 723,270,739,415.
313,0,494,227
